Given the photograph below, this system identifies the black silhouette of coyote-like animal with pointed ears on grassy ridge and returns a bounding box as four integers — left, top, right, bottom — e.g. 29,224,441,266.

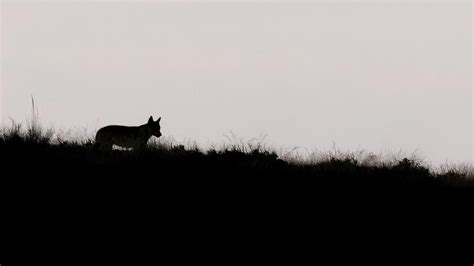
95,116,161,150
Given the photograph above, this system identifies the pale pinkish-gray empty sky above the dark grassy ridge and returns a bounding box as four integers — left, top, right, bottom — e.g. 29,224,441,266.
0,0,473,163
